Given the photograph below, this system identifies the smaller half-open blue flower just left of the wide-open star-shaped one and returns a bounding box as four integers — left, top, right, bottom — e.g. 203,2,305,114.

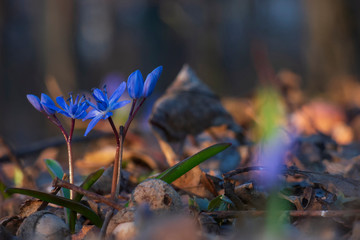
56,94,89,119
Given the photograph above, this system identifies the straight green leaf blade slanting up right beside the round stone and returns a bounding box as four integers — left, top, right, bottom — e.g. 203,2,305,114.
156,143,231,183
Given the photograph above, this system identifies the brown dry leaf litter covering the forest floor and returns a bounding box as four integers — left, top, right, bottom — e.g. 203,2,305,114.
0,65,360,239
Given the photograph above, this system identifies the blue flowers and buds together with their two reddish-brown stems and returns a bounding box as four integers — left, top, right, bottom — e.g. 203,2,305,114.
27,66,162,203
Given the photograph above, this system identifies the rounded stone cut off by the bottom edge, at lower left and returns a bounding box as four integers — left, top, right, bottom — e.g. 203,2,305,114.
17,211,70,240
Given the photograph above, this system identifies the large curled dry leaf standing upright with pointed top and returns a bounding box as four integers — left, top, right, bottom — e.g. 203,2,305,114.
149,65,243,166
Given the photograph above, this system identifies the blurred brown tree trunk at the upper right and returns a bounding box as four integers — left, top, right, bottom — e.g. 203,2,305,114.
305,0,355,94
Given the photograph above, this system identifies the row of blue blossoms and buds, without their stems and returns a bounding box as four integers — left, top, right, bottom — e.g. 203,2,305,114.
27,66,163,136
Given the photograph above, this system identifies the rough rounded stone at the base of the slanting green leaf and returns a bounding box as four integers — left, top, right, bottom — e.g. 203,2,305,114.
129,179,182,213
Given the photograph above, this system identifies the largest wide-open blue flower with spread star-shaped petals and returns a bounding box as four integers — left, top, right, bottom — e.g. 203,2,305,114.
83,82,130,136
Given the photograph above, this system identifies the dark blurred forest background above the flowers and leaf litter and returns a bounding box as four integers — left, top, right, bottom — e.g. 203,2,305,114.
0,0,360,148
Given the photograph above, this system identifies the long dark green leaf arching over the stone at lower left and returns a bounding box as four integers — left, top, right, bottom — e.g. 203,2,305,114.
6,188,102,227
